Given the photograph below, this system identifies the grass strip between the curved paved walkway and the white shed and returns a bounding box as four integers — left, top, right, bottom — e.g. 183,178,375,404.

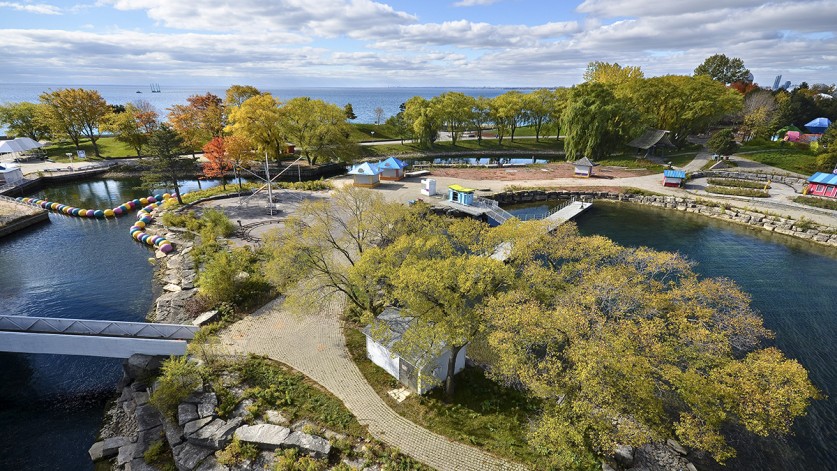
344,326,540,469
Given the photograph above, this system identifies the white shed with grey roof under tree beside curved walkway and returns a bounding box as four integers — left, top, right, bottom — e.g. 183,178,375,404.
363,307,467,394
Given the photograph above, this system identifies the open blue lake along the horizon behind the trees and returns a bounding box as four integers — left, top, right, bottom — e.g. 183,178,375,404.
0,83,531,130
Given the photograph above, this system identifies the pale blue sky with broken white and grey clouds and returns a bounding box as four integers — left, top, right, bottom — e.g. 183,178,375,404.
0,0,837,87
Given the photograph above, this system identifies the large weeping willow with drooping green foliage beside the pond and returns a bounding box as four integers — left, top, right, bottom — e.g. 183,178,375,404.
561,83,642,160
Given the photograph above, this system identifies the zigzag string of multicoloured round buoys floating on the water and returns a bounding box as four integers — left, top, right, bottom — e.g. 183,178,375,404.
17,193,174,253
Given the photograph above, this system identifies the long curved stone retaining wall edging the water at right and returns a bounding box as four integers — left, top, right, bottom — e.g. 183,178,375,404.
489,190,837,247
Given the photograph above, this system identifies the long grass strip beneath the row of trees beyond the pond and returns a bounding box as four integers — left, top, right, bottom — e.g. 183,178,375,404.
361,138,564,157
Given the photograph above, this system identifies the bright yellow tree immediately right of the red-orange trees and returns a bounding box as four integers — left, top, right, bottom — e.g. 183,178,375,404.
226,93,287,159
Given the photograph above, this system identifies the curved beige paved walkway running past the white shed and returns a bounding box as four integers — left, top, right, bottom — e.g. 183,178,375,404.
222,297,526,471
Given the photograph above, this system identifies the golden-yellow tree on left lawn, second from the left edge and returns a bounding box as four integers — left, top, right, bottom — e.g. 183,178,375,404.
40,88,110,157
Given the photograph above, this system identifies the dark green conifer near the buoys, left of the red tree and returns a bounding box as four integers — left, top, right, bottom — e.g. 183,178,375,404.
142,124,195,204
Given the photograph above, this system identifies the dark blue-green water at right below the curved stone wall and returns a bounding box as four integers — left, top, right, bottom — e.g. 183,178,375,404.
507,203,837,471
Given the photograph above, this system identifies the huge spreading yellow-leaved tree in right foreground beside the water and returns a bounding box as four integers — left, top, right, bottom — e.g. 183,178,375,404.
485,222,818,469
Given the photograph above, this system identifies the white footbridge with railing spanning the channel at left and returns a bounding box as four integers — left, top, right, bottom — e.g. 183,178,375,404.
0,315,198,358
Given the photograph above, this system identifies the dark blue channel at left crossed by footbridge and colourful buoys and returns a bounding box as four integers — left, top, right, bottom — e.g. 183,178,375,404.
0,179,222,471
